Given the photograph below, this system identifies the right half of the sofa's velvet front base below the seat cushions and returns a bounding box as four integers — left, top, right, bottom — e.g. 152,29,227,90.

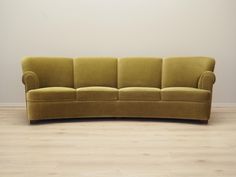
118,101,210,120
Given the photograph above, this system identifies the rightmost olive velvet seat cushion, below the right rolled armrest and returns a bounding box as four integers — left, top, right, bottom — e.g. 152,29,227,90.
161,87,211,102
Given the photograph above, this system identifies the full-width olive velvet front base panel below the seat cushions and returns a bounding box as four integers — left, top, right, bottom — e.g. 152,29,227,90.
27,101,210,120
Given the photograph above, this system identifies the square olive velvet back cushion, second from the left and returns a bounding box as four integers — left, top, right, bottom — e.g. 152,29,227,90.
74,57,117,88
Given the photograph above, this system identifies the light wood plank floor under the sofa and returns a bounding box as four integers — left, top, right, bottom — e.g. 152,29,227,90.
0,108,236,177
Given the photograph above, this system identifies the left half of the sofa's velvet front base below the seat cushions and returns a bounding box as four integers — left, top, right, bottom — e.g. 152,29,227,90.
27,101,118,120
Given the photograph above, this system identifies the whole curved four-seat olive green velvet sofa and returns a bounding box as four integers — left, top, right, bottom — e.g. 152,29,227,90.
22,57,215,123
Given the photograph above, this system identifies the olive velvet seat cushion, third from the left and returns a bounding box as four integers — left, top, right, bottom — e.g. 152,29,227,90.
119,87,161,101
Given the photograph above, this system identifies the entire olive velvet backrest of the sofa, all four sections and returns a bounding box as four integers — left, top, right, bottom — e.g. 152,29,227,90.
22,57,215,88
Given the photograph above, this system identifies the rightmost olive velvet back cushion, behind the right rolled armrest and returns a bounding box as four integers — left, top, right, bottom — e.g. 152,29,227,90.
162,57,215,88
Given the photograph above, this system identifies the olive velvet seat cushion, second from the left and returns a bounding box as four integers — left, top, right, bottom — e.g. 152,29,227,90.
76,87,118,101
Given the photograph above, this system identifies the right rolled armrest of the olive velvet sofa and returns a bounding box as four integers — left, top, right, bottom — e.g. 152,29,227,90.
198,71,216,91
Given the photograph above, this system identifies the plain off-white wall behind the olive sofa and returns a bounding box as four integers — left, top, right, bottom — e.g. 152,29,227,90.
0,0,236,103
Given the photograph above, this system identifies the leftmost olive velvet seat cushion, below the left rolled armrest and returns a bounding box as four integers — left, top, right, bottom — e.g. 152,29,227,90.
27,87,76,101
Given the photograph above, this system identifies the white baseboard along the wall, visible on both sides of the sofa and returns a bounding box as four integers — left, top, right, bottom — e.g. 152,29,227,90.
0,102,236,108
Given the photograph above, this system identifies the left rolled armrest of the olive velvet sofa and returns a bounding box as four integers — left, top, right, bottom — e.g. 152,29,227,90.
22,71,39,92
